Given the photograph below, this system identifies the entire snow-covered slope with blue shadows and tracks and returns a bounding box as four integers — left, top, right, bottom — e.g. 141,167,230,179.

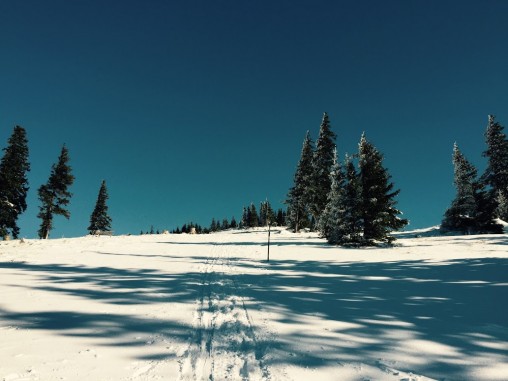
0,229,508,381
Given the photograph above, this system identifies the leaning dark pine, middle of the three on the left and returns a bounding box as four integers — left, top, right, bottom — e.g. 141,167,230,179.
37,145,74,239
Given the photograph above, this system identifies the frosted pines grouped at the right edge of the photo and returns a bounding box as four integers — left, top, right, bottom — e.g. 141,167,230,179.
441,115,508,234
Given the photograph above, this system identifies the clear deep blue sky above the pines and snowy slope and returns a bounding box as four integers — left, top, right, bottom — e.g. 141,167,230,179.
0,0,508,238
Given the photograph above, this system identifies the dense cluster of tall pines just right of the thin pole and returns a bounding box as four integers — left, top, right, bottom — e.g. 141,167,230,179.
286,113,408,246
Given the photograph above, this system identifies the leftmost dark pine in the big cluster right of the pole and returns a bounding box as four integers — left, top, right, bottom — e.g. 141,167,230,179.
286,131,314,233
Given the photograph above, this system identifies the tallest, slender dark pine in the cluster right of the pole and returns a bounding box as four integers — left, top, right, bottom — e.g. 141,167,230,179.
310,112,336,221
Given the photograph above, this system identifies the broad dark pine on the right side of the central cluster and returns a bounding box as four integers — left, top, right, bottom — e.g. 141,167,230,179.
359,134,408,244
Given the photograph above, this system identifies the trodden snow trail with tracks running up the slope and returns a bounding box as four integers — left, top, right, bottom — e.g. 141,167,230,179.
178,243,270,381
